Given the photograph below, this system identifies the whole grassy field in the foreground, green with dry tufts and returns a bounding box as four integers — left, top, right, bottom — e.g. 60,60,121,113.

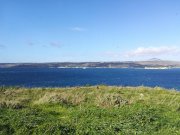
0,86,180,135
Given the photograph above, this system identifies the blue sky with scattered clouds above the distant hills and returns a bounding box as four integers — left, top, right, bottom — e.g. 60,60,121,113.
0,0,180,63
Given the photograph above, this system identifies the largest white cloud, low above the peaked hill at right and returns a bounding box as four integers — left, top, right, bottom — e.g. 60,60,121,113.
125,46,180,57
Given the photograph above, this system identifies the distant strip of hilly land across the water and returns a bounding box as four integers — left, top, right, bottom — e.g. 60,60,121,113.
0,58,180,68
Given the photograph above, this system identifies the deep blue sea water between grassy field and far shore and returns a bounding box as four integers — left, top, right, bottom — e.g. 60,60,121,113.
0,68,180,90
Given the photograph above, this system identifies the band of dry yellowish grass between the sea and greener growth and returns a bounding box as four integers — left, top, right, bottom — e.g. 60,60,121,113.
0,86,180,108
